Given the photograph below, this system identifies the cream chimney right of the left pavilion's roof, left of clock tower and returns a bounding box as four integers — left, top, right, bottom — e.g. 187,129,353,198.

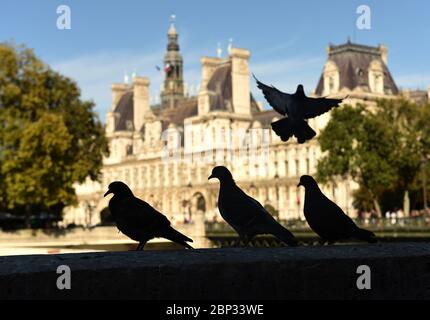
133,76,150,131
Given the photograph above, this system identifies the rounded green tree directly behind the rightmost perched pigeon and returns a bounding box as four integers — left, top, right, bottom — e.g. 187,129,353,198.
317,104,395,214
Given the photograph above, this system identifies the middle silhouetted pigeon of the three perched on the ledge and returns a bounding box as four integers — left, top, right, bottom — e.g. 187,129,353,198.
208,166,297,246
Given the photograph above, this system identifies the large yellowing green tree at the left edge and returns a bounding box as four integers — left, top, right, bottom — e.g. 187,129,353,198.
0,43,108,224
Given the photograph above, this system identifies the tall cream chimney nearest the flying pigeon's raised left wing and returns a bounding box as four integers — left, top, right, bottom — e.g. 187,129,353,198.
230,48,251,115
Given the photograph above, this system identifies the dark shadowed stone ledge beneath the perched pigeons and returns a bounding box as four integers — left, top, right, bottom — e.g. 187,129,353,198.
0,243,430,300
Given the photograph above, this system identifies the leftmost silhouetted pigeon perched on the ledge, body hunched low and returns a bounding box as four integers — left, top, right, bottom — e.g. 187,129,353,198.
104,181,193,250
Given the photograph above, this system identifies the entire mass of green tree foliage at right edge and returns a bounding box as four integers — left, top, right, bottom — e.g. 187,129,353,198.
317,99,430,212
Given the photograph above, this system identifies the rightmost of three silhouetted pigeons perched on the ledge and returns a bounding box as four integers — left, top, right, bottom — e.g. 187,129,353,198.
297,175,376,243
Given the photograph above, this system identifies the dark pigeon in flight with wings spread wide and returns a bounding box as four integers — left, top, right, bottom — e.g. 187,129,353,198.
253,75,346,143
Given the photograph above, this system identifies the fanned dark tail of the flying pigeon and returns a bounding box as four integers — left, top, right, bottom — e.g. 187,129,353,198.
271,117,316,143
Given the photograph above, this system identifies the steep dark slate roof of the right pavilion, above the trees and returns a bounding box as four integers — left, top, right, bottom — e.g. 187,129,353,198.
315,42,399,95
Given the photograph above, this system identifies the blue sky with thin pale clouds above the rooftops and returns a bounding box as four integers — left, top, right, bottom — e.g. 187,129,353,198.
0,0,430,119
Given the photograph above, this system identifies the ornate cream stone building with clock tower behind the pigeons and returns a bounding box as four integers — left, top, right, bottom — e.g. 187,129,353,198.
64,24,428,225
